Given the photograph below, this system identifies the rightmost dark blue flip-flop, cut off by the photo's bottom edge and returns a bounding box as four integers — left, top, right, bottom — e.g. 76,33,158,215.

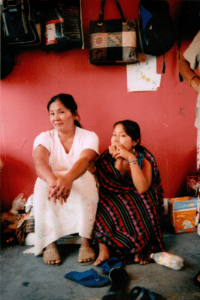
130,286,163,300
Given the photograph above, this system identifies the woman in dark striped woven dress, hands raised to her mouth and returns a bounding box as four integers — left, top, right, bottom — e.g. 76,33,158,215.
93,120,164,265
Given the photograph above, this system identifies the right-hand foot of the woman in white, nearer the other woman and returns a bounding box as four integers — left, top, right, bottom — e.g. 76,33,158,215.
78,237,95,263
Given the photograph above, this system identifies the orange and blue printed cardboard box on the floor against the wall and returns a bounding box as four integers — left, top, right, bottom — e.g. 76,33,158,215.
168,196,197,233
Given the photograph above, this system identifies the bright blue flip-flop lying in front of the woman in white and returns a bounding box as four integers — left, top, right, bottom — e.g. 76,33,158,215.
65,269,110,287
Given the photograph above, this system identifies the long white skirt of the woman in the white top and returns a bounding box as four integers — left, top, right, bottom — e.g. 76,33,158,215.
33,171,98,255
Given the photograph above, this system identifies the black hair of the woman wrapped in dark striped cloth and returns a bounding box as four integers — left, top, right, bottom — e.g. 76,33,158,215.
113,120,143,151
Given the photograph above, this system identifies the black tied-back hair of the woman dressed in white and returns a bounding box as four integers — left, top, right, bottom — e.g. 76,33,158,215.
47,94,81,127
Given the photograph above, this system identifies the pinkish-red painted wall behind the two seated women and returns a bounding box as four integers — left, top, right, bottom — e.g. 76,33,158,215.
0,0,197,210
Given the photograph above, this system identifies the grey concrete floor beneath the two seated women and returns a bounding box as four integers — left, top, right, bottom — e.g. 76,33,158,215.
0,233,200,300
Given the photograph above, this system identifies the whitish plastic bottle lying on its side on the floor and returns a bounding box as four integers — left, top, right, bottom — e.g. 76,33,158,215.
150,252,183,270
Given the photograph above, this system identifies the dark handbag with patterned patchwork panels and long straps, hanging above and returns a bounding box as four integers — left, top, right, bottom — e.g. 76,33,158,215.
89,0,137,65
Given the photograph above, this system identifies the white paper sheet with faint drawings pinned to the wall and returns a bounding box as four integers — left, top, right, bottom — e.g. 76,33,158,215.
126,55,161,92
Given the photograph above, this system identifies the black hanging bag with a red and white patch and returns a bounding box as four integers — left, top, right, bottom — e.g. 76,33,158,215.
42,0,84,53
